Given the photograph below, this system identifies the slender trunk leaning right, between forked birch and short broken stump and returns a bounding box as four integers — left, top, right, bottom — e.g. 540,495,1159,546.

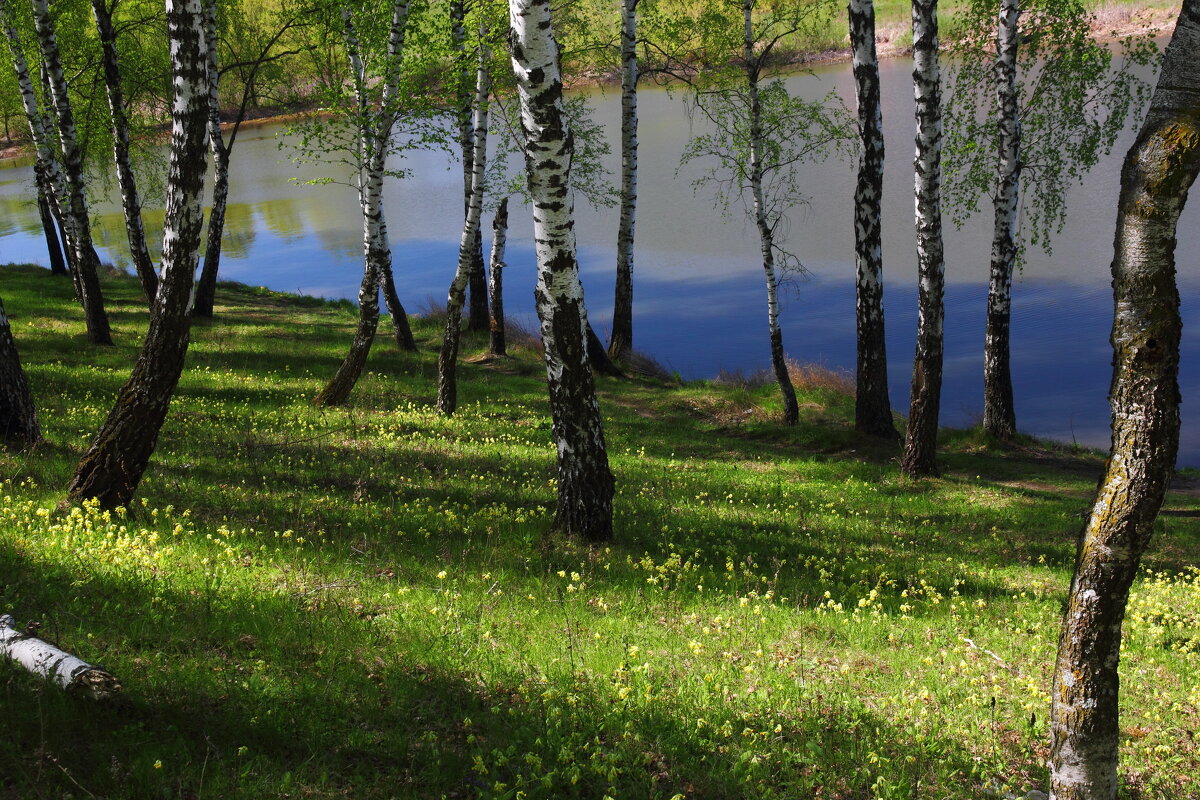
437,44,492,415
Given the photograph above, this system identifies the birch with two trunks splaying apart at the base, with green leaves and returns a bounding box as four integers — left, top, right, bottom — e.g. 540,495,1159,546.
295,0,427,405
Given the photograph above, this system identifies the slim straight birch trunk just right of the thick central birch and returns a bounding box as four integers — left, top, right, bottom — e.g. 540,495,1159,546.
608,0,637,359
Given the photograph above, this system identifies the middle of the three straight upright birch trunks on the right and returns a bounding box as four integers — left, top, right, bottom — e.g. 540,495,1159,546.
900,0,946,477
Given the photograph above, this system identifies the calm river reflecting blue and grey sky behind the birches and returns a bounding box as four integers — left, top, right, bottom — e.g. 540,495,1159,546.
0,59,1200,467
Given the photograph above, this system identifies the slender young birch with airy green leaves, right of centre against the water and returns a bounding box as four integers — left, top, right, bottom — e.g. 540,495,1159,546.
683,0,853,425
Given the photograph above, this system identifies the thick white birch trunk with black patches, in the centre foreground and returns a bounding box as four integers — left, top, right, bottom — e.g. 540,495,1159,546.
509,0,613,542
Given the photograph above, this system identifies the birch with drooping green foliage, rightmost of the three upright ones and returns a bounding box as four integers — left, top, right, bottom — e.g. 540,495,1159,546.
946,0,1157,439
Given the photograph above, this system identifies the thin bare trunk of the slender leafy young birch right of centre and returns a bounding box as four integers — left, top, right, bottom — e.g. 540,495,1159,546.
742,0,800,425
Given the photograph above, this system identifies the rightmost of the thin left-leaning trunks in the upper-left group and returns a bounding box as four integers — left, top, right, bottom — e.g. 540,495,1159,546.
91,0,157,306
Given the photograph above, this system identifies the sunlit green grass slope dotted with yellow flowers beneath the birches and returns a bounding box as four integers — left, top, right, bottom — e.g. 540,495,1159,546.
0,267,1200,800
